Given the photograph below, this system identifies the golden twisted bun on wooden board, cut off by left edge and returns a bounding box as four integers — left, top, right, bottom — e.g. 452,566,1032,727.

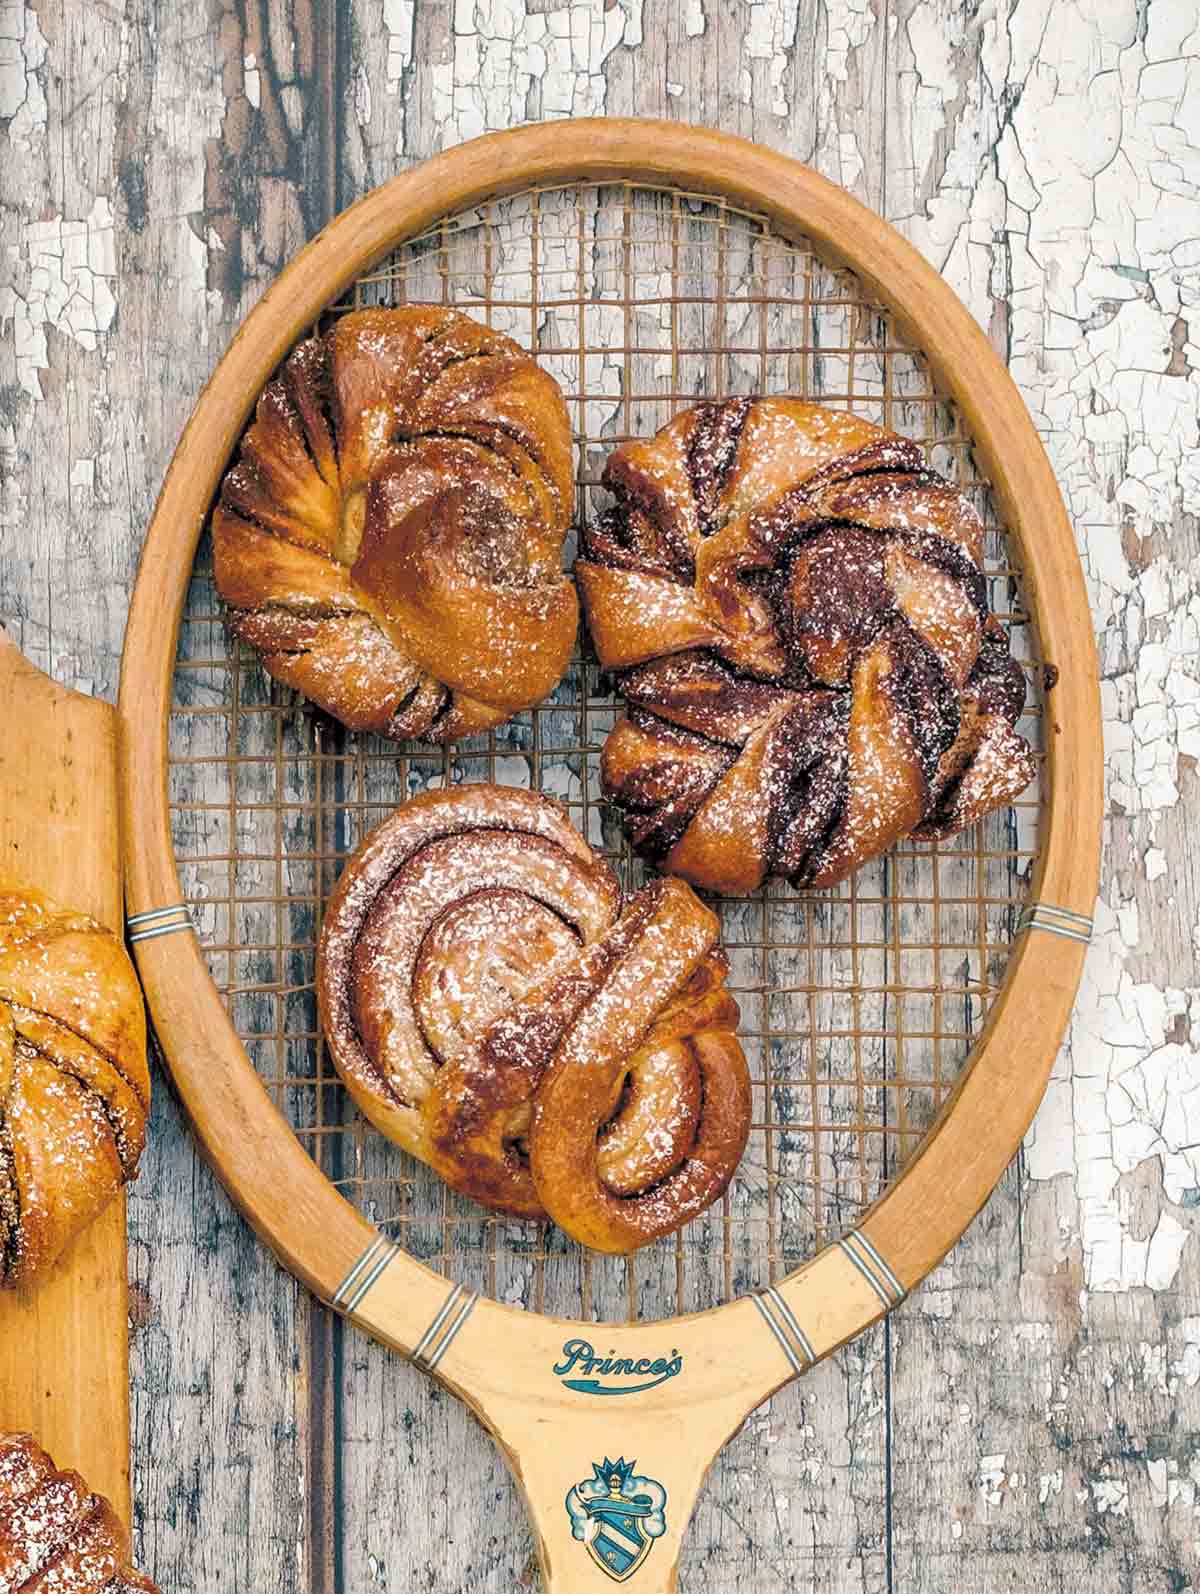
0,880,150,1287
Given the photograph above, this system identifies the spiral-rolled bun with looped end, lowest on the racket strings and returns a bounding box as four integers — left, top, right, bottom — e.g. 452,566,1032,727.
317,786,749,1251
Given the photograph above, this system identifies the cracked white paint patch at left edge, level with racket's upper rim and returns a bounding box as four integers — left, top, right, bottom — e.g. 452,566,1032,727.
0,194,116,399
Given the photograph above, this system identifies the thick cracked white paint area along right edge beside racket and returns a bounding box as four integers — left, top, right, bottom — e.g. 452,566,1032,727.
902,0,1200,1290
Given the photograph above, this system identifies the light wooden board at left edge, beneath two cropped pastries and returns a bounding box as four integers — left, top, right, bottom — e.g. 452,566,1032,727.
0,631,129,1524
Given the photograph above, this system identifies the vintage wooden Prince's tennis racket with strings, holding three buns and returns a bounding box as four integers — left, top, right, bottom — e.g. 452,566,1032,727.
121,120,1101,1591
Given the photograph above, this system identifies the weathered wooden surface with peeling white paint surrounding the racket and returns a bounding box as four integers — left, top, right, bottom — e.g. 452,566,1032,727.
0,0,1200,1594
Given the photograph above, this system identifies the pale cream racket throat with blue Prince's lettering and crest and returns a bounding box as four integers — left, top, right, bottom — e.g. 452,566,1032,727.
374,1281,822,1594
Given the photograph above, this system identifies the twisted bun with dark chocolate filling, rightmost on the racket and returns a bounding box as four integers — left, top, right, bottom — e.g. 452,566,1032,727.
575,399,1034,893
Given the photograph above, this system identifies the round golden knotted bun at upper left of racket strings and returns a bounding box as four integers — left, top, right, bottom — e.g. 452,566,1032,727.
212,306,578,741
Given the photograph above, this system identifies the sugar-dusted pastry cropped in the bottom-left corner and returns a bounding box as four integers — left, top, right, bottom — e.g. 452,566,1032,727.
0,1433,158,1594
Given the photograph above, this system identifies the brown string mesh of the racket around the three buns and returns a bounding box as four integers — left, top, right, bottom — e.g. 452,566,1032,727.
169,183,1042,1318
